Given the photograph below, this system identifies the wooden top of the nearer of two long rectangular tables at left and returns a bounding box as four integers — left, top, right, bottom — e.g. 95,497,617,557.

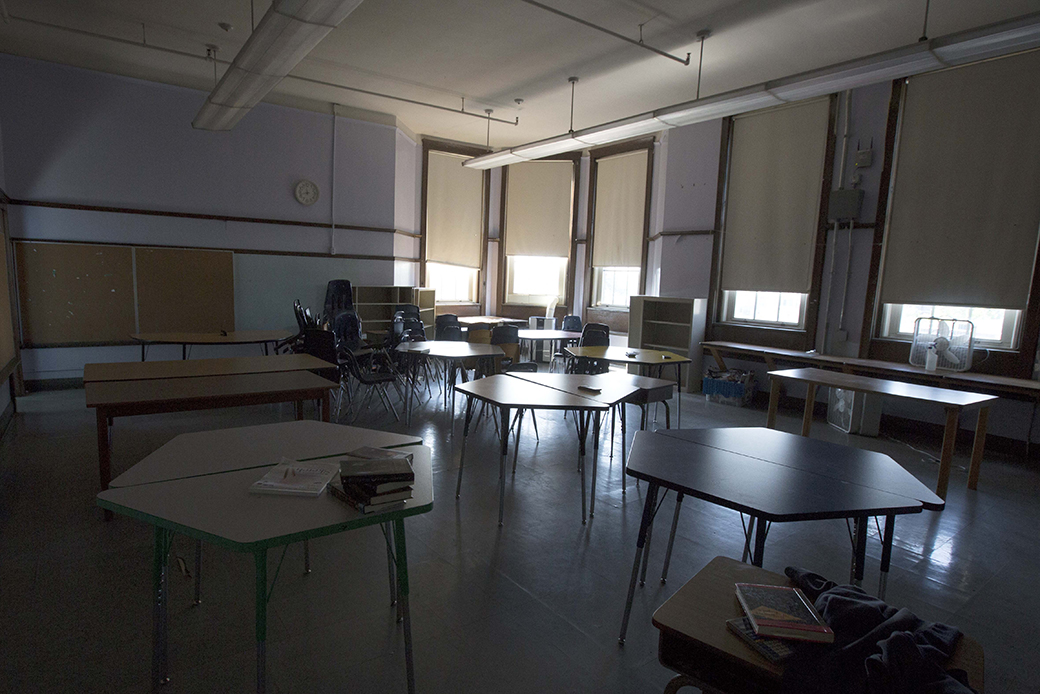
85,371,336,413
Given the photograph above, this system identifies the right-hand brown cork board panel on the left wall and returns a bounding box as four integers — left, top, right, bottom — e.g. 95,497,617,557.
135,248,235,333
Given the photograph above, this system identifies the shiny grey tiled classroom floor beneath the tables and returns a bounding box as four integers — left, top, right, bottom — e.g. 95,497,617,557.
0,374,1040,694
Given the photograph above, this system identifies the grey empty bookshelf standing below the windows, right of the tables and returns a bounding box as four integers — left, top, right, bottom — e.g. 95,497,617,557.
628,297,707,392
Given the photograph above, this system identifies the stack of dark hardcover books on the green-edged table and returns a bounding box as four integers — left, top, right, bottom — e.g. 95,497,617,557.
329,446,415,513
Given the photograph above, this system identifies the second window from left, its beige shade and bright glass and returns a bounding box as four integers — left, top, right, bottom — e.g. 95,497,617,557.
503,160,574,306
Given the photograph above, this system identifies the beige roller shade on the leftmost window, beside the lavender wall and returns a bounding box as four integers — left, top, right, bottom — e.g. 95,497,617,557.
426,151,484,267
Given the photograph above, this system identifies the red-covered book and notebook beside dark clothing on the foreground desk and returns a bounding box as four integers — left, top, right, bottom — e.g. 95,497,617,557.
726,583,834,663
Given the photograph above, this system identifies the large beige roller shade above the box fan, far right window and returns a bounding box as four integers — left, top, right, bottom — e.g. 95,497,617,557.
881,52,1040,309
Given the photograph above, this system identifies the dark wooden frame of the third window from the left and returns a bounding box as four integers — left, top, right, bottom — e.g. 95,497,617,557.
581,137,656,332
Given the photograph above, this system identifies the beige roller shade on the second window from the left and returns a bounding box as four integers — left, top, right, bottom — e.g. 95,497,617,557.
505,161,574,258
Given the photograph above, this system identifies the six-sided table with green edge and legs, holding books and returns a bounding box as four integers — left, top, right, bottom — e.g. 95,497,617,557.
98,422,434,693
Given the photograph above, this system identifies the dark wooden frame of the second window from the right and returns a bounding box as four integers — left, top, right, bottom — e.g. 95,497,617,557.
706,94,838,352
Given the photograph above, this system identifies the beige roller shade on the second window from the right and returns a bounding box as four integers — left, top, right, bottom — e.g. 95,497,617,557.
722,98,830,293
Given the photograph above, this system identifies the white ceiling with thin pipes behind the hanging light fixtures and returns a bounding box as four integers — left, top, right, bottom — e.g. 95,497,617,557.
0,0,1040,149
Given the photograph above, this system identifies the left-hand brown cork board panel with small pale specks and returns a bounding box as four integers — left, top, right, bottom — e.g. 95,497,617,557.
15,241,136,348
